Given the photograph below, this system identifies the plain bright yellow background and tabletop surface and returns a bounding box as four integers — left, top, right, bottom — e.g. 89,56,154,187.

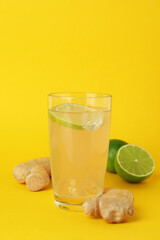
0,0,160,240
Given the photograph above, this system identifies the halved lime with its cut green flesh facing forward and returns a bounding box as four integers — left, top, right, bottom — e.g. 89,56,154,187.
115,144,155,182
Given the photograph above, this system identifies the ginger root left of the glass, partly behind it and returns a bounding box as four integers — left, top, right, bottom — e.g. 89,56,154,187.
13,158,51,191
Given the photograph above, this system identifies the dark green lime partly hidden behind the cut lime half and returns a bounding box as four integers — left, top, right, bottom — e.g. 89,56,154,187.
107,139,127,173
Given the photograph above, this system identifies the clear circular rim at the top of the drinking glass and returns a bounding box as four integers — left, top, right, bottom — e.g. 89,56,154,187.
48,92,112,99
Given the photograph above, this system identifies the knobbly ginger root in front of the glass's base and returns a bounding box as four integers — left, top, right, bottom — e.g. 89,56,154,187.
83,188,134,223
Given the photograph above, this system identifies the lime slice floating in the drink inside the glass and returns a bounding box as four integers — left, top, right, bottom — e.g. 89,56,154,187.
49,104,103,131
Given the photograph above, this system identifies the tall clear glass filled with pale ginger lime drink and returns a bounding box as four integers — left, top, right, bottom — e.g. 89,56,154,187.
49,93,111,211
